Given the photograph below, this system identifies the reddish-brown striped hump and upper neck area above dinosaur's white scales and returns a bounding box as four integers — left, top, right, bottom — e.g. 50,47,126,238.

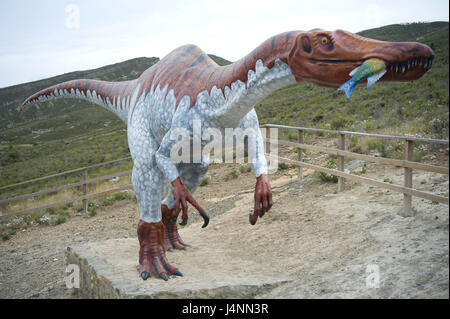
162,31,300,115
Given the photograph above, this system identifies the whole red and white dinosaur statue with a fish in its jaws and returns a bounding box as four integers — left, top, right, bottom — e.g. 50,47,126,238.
19,29,434,280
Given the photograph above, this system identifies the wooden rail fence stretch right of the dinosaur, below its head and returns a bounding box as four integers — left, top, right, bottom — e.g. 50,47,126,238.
263,124,449,216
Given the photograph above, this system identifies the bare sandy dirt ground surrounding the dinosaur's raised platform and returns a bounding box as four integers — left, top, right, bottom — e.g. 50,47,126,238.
0,160,449,298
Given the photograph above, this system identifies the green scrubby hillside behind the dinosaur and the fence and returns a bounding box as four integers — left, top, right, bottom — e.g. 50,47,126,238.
0,22,449,190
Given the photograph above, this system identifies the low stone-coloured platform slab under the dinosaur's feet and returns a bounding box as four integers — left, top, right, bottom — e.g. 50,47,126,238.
66,238,286,298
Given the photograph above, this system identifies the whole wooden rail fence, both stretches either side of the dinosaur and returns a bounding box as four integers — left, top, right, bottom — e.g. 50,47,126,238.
0,124,449,219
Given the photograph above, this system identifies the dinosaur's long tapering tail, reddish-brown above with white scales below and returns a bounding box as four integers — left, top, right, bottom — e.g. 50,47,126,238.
18,79,139,123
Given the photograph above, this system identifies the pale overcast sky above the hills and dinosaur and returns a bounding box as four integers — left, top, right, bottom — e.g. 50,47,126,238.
0,0,449,87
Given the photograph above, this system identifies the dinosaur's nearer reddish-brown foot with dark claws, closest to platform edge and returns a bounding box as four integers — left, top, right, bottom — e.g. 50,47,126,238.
138,220,183,281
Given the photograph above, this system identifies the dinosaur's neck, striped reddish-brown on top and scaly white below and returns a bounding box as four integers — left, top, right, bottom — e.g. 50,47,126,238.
201,32,299,127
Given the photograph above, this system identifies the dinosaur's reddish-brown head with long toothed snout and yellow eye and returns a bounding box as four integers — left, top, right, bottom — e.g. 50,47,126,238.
288,29,434,87
